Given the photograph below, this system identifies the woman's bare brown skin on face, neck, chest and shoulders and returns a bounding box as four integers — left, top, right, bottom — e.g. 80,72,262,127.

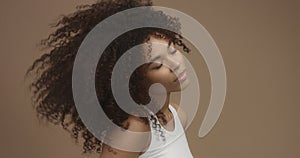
100,36,189,158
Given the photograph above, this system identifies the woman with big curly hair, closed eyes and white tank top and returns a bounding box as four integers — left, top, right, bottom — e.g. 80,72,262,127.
27,0,192,158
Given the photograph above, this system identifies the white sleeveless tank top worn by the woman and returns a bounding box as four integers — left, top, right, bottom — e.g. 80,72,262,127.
139,105,193,158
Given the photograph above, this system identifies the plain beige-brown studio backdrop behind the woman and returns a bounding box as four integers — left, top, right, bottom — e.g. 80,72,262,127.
0,0,300,158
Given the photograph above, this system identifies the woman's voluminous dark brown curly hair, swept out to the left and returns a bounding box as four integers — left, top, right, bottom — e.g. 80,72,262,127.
26,0,190,153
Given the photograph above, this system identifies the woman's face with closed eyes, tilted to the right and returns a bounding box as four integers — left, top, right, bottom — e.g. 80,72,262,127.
146,36,189,92
